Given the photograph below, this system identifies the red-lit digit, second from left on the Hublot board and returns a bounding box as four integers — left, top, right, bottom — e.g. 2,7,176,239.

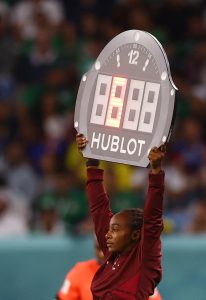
105,77,127,128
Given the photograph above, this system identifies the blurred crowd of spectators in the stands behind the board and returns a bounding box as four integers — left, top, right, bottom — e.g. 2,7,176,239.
0,0,206,237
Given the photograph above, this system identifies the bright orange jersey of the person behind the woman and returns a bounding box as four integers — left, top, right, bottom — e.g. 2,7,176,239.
58,259,162,300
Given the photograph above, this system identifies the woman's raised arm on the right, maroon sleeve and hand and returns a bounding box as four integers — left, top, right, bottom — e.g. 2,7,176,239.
143,146,165,285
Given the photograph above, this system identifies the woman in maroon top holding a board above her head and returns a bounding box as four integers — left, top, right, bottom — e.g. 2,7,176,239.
76,133,165,300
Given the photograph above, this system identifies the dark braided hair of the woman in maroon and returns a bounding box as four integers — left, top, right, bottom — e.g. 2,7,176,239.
120,208,143,230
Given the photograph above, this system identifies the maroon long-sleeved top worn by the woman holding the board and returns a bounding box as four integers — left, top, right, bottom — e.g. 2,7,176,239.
87,168,164,300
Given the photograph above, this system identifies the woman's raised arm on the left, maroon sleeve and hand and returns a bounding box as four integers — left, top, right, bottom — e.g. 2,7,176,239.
76,134,113,257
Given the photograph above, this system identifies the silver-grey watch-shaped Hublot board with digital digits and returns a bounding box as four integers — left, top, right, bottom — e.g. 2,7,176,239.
74,30,177,167
